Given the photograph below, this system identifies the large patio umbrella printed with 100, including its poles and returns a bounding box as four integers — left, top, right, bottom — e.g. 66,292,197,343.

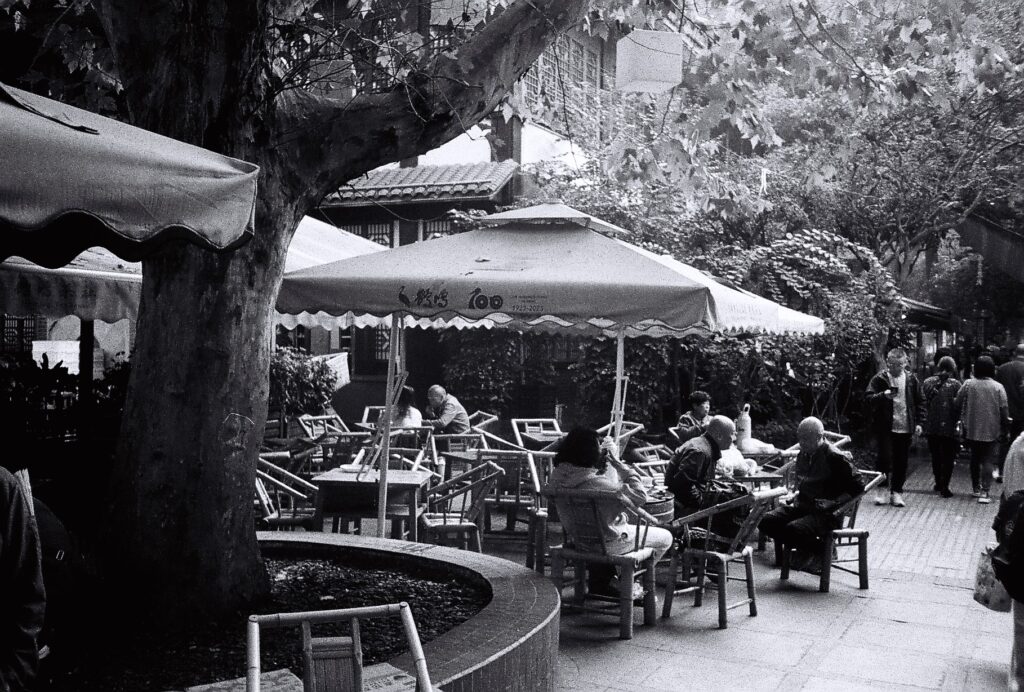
278,205,824,536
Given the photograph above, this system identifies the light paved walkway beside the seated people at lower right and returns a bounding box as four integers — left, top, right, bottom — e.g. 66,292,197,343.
486,450,1012,692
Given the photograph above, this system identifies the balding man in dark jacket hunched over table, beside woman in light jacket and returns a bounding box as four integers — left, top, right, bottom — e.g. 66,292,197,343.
665,416,736,517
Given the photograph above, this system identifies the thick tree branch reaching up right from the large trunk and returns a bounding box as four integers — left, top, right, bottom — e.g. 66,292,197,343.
276,0,588,201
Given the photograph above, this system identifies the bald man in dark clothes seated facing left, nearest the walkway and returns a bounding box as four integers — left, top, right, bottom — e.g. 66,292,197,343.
760,418,864,570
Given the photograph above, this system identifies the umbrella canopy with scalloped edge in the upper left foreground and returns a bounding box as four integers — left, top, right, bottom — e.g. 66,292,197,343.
0,84,259,267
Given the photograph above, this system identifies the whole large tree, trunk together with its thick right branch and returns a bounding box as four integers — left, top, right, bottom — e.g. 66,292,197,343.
98,0,587,620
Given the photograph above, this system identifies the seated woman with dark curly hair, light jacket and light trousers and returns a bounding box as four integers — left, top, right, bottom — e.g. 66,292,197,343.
548,428,672,595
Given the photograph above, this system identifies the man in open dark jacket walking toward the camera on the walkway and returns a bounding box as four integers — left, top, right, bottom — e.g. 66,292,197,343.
867,348,925,507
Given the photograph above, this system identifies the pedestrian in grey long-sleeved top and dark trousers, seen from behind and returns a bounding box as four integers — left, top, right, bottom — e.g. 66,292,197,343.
956,355,1010,505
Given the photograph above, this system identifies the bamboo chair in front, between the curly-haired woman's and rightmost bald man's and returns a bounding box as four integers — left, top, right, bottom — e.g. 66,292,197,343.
662,487,786,630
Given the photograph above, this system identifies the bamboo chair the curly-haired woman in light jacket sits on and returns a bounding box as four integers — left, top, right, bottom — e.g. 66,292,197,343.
544,487,657,639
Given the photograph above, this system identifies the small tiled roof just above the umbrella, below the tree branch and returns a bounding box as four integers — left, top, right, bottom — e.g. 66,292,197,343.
325,161,518,206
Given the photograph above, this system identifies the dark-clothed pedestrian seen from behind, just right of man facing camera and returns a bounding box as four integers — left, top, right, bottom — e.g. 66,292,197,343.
922,355,961,498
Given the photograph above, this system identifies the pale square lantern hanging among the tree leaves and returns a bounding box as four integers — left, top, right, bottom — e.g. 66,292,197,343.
615,29,690,93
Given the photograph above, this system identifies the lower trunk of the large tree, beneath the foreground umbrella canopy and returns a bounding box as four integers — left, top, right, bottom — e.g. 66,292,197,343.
108,177,295,620
